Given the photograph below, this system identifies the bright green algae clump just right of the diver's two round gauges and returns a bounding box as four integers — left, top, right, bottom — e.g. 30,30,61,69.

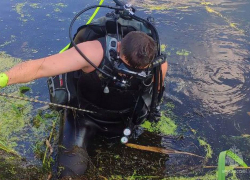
141,115,177,135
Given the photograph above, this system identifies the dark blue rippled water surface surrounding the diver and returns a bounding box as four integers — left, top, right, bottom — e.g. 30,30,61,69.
0,0,250,179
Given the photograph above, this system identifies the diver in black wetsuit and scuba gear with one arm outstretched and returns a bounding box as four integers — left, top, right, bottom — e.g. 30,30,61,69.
0,0,167,177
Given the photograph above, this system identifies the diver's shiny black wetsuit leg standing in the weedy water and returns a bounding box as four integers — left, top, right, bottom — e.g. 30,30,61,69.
58,110,96,178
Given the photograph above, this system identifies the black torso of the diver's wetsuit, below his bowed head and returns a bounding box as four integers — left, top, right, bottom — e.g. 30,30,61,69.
77,37,151,121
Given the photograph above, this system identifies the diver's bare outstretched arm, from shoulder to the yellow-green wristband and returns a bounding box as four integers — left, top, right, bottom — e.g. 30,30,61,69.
5,41,103,85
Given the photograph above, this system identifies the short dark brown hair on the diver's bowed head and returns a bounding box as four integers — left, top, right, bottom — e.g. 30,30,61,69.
120,31,157,68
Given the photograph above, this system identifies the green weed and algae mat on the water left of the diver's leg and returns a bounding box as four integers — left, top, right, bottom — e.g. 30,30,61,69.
0,52,59,179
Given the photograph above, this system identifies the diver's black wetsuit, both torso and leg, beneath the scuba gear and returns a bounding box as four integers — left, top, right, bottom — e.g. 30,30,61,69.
58,38,152,177
